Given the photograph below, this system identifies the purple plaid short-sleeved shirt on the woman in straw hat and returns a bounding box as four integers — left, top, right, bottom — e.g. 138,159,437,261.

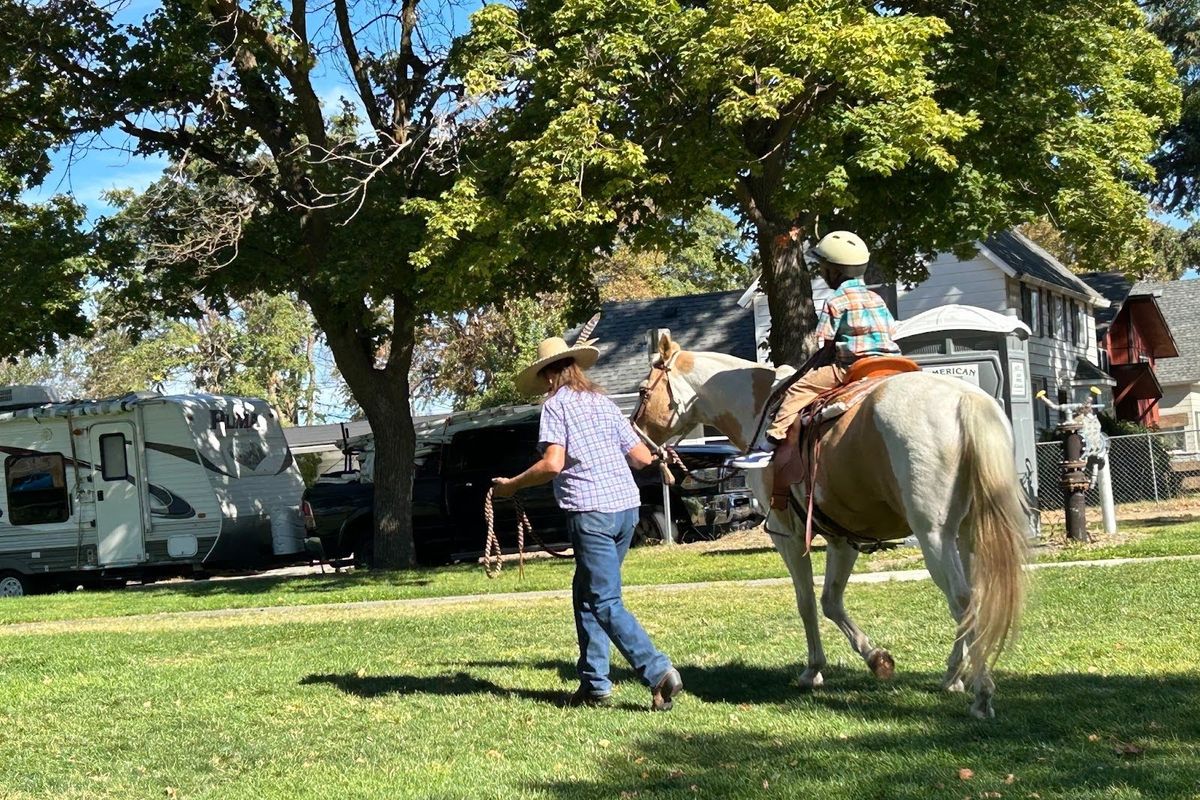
538,386,642,512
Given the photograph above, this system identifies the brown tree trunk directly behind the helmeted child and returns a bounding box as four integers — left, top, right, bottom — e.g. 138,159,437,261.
758,223,817,367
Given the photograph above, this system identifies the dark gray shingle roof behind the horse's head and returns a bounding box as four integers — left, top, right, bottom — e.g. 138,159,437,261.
565,291,756,395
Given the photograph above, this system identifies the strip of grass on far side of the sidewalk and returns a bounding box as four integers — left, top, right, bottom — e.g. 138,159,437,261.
0,522,1200,625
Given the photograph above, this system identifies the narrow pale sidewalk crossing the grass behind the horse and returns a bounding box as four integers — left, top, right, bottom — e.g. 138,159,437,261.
0,555,1200,637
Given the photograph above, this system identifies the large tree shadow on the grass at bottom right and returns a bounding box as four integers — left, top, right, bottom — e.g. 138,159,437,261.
529,664,1200,800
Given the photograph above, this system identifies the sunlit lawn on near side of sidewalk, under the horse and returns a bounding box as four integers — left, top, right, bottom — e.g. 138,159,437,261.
0,563,1200,800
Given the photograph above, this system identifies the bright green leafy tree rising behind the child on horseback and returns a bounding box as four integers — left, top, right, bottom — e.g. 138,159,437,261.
466,0,1178,362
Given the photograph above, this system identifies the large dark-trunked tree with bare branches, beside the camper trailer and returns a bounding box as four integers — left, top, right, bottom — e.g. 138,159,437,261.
2,0,587,566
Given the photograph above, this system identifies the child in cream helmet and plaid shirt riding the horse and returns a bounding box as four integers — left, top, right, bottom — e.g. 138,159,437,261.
730,230,900,469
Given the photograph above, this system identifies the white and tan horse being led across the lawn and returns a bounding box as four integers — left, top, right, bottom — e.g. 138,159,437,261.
636,336,1028,717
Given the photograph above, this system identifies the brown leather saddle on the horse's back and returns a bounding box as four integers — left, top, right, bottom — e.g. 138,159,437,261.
770,355,920,509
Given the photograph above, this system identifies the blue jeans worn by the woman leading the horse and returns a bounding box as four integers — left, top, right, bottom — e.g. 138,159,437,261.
566,509,671,694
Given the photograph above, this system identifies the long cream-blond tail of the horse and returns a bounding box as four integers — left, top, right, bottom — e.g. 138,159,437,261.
959,391,1028,679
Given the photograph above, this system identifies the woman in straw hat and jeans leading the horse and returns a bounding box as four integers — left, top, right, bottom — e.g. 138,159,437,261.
492,336,683,711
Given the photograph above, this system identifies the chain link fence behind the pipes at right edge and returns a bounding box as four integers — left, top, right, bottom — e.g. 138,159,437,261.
1037,431,1200,517
